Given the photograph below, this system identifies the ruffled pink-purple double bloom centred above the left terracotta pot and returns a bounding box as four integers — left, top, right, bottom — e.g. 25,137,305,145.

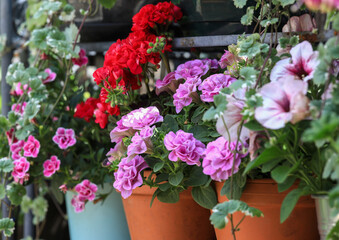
164,130,205,166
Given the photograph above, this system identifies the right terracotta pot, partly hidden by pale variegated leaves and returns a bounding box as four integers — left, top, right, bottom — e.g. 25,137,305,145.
215,179,319,240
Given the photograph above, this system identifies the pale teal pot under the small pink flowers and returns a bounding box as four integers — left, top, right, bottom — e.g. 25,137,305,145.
66,184,130,240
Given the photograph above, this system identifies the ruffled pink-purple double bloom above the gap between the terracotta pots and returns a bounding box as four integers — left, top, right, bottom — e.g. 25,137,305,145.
202,137,247,181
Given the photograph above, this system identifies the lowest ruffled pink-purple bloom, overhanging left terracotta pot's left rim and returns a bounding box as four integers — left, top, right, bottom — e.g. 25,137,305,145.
113,155,148,199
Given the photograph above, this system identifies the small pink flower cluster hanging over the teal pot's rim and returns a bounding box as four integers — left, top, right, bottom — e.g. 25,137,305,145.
71,179,98,213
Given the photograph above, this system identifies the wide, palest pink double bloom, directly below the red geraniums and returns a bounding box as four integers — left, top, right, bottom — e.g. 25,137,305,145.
110,107,163,143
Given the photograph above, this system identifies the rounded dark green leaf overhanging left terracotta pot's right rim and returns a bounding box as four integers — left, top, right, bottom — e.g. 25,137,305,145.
192,185,218,209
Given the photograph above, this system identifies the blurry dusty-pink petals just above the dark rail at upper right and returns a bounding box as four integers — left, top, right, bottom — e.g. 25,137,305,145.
282,13,317,32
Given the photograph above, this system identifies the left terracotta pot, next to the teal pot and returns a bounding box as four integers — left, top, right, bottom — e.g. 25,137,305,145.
122,186,215,240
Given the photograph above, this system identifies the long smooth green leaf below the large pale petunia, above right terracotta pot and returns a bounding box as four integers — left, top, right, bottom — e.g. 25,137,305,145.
244,146,286,174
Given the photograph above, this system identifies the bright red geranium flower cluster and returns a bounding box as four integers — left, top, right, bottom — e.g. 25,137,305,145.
80,2,182,128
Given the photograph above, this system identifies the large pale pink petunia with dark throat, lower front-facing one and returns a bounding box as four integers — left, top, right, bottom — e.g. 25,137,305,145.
255,78,309,129
